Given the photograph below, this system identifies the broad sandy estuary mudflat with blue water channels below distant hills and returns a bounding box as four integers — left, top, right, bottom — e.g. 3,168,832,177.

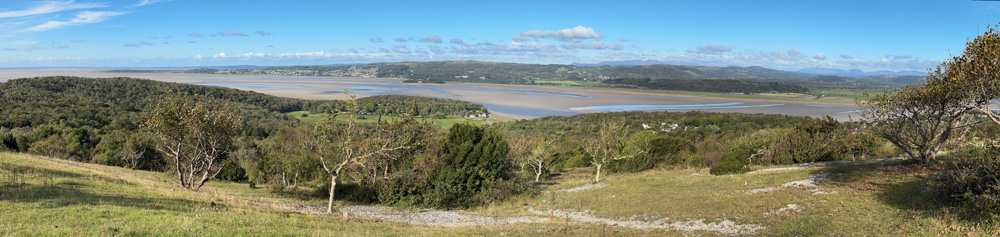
0,69,859,120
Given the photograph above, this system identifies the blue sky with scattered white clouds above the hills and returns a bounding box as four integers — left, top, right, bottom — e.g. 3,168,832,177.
0,0,1000,72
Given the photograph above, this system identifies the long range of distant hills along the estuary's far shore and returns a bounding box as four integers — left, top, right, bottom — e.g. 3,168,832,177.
178,61,920,88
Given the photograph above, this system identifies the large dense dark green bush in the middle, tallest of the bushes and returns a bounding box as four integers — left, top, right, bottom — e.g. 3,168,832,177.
375,124,530,208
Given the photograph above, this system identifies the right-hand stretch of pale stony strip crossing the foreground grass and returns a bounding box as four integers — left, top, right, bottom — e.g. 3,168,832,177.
528,207,766,235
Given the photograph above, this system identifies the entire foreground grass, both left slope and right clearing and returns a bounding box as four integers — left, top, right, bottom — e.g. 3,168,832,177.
0,153,1000,236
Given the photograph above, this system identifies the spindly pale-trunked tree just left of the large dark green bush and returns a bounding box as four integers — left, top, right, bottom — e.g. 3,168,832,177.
313,93,416,213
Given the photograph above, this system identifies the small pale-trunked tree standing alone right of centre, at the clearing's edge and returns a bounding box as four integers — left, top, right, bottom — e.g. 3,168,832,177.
583,120,644,182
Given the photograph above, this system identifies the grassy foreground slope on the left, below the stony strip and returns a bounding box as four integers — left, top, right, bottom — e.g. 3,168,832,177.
0,153,642,236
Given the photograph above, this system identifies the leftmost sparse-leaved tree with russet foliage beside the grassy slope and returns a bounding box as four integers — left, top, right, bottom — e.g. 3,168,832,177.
143,93,243,191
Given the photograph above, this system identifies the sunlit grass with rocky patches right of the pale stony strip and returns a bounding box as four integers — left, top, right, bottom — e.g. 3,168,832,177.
535,161,1000,236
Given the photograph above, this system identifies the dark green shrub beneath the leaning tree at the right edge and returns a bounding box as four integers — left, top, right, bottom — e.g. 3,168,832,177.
931,147,1000,214
